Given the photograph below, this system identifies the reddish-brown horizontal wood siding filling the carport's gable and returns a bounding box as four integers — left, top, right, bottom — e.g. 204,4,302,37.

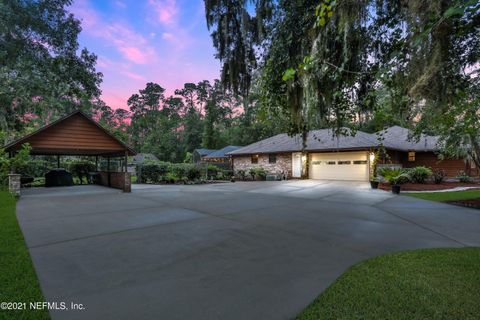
11,114,125,155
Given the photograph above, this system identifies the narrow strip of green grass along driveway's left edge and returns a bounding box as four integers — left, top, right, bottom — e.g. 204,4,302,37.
0,191,50,319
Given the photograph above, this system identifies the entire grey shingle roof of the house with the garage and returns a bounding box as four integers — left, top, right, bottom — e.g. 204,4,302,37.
228,126,438,155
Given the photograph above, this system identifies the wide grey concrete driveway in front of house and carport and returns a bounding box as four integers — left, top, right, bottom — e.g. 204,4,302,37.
17,180,480,320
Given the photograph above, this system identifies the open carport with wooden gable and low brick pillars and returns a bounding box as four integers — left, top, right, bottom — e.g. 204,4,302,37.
5,110,136,193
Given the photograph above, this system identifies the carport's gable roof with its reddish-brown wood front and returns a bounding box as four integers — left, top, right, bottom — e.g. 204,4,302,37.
4,110,136,156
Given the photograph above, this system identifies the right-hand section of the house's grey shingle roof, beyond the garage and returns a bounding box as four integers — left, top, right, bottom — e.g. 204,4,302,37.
376,126,439,151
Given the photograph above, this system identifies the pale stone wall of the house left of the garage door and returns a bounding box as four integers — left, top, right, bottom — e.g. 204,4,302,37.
233,153,292,178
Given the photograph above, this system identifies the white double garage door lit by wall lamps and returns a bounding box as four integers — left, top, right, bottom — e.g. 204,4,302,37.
309,152,368,181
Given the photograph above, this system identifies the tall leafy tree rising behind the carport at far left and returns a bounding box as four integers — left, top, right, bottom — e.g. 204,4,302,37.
0,0,102,141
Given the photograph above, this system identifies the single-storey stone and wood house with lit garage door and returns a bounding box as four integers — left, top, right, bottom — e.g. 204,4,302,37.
228,126,478,181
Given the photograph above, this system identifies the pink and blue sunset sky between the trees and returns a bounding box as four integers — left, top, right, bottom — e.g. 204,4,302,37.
70,0,220,109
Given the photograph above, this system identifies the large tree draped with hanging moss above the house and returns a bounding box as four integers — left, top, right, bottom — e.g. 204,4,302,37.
205,0,480,140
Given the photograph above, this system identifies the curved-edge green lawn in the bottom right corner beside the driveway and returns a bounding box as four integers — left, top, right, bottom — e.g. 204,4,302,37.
297,248,480,320
